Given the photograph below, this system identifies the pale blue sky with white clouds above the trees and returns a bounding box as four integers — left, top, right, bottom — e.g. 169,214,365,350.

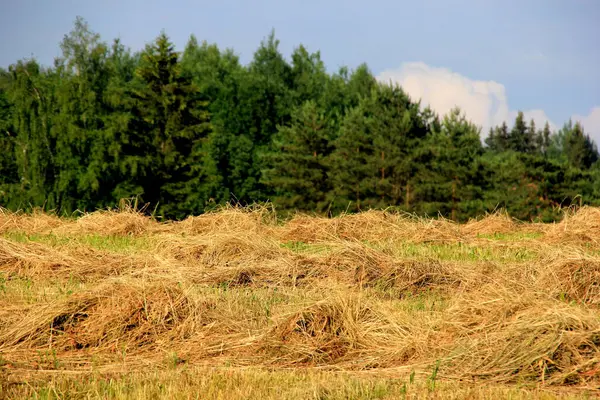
0,0,600,143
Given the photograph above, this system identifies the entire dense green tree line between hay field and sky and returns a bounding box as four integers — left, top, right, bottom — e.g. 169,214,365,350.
0,18,600,221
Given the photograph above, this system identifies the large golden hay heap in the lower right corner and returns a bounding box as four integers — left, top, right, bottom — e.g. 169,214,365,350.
445,285,600,384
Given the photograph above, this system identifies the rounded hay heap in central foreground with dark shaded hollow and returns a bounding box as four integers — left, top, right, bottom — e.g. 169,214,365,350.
260,295,425,369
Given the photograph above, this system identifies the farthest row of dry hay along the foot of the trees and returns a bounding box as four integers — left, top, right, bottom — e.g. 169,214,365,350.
0,207,600,246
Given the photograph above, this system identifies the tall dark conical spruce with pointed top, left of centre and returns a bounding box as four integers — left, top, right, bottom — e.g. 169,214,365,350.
132,33,209,218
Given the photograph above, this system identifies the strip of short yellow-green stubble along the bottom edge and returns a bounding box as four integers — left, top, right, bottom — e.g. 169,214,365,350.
0,365,593,400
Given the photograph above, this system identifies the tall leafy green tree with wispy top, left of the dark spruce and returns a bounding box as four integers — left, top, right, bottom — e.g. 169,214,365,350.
50,19,112,212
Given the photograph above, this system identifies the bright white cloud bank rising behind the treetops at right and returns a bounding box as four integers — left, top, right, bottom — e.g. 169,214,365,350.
377,62,600,142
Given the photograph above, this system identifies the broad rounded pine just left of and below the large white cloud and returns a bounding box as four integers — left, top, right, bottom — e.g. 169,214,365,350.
330,85,427,210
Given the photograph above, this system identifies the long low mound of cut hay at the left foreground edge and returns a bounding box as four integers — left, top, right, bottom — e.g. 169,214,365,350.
0,281,214,351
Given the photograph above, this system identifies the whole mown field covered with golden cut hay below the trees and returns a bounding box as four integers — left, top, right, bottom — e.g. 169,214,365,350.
0,207,600,399
